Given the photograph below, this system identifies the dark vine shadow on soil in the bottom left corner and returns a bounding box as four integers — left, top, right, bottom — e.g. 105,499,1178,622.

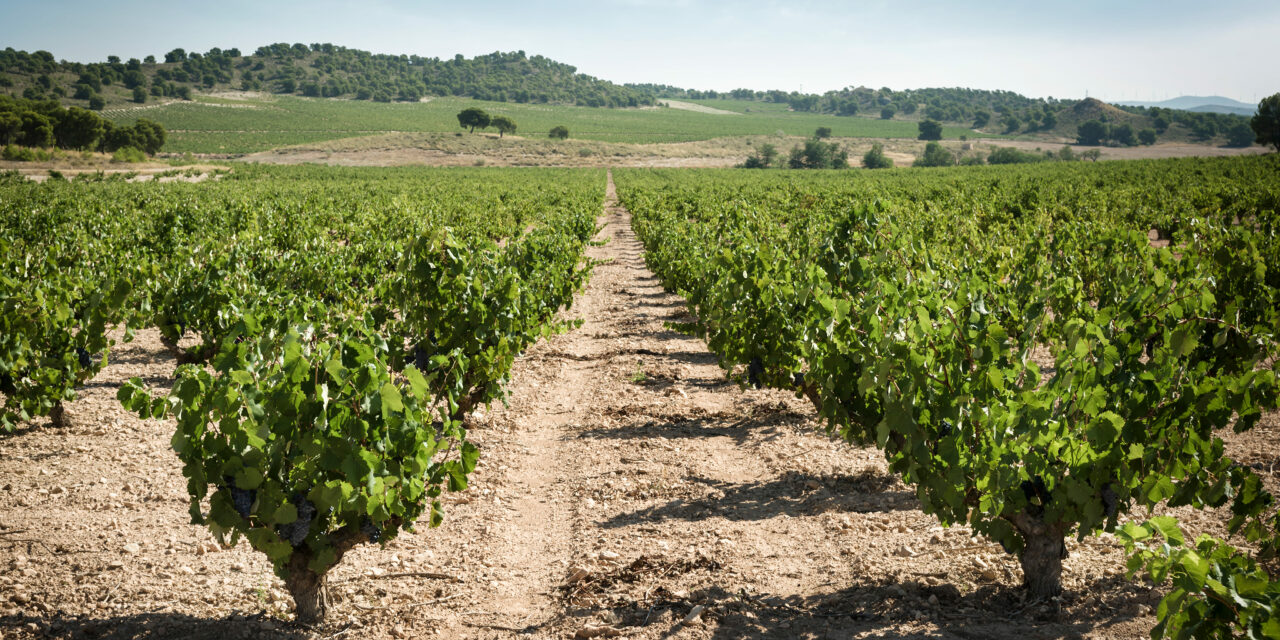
0,613,312,640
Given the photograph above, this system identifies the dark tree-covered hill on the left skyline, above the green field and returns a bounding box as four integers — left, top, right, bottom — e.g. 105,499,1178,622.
0,44,653,110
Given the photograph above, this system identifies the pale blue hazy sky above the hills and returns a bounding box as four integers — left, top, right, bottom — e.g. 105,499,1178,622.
0,0,1280,102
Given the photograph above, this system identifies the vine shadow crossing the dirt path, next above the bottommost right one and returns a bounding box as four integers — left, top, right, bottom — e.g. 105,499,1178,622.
600,471,919,529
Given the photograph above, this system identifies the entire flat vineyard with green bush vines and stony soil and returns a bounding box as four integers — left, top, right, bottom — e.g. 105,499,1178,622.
0,155,1280,637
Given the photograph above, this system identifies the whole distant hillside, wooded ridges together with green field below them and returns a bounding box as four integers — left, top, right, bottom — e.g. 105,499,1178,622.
0,44,1252,154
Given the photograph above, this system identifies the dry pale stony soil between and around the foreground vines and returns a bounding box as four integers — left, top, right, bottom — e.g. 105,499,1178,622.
0,171,1276,640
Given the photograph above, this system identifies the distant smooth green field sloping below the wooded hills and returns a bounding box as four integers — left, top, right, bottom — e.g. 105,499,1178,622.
104,96,993,154
